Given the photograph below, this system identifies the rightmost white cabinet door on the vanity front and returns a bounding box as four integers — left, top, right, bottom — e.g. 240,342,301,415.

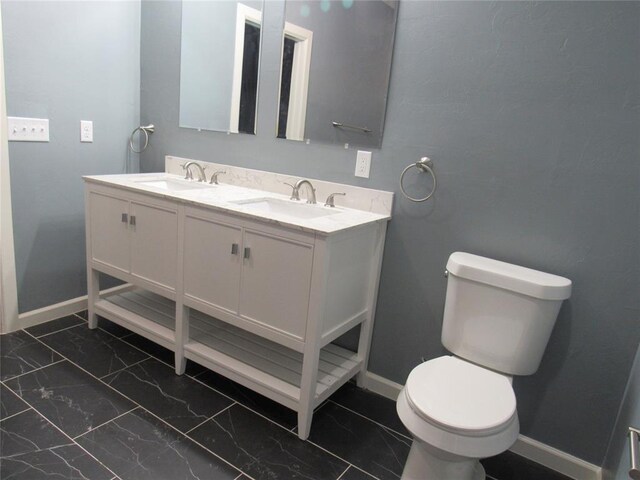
239,228,313,341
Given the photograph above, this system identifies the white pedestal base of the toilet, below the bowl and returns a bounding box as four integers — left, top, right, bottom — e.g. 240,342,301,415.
401,440,485,480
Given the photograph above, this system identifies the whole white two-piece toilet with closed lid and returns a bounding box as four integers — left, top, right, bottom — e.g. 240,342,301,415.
397,252,571,480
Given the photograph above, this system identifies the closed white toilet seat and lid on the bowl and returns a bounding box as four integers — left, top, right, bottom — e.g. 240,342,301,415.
405,356,517,436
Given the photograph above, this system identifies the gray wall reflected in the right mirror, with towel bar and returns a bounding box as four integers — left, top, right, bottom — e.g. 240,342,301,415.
285,1,396,148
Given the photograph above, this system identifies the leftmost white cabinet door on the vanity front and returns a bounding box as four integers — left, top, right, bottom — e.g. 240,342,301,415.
89,192,129,273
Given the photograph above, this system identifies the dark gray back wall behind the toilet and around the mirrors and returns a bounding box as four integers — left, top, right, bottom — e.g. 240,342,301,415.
141,1,640,464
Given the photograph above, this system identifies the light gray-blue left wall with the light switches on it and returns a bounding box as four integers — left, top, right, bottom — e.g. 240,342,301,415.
2,1,140,312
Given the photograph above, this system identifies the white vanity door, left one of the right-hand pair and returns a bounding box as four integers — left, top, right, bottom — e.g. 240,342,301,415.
184,213,242,314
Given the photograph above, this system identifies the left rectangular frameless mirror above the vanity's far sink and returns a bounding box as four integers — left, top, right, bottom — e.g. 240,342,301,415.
179,0,262,134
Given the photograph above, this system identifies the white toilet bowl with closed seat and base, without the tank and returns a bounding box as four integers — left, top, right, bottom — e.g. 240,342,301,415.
397,356,519,480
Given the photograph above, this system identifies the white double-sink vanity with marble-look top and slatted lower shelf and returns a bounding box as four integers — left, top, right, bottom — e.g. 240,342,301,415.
84,157,393,439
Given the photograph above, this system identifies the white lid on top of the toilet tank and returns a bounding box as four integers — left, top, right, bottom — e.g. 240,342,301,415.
447,252,571,300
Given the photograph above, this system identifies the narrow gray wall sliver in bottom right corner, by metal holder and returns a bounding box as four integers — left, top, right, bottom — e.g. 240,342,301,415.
603,348,640,480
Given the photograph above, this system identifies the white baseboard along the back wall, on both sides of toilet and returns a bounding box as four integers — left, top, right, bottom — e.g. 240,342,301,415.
365,372,602,480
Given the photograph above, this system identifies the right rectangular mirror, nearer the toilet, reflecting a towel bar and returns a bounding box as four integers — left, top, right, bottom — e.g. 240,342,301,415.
277,0,398,147
